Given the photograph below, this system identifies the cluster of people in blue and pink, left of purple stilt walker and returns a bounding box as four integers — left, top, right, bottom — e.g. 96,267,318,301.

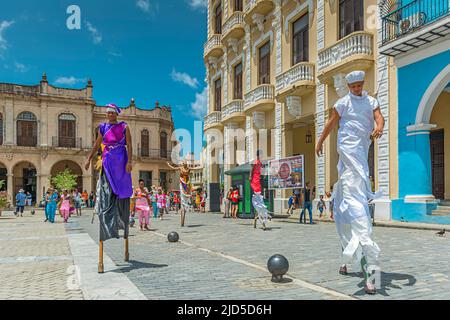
44,188,83,223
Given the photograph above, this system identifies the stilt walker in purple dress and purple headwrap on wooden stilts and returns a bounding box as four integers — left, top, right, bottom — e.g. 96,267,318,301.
85,104,133,273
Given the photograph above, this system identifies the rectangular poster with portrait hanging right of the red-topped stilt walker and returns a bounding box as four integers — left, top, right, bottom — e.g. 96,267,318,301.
269,155,305,190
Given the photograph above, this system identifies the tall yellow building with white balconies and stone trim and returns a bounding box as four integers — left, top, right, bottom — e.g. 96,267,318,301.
204,0,397,220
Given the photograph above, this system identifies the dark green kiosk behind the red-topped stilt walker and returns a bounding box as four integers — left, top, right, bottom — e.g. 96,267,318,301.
224,161,274,219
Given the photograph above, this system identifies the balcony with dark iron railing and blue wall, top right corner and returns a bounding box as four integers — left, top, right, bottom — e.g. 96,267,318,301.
380,0,450,56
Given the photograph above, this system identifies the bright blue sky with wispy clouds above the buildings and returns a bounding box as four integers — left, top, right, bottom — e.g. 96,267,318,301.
0,0,207,159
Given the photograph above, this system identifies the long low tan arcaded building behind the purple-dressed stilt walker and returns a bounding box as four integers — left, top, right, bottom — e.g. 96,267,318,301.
0,75,178,205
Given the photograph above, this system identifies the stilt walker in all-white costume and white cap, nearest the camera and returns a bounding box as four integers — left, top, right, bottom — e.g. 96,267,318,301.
316,71,384,294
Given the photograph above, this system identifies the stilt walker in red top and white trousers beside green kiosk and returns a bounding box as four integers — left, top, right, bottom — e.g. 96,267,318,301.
250,150,272,230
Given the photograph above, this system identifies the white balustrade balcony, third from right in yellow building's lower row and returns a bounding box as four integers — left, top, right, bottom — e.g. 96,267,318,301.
244,84,275,113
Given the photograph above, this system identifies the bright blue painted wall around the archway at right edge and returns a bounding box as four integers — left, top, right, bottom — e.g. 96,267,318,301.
398,50,450,224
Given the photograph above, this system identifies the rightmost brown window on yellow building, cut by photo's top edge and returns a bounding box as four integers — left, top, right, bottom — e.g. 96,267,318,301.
339,0,364,39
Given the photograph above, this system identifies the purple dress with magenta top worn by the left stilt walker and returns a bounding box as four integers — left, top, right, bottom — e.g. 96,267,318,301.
99,121,133,199
